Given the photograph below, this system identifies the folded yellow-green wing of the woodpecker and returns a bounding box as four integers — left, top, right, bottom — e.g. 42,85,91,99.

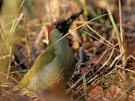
13,49,55,92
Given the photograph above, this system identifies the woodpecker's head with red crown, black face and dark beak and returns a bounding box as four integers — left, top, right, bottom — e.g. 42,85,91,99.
48,11,83,39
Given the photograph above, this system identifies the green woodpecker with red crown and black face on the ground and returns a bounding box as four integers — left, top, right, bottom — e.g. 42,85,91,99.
13,11,83,92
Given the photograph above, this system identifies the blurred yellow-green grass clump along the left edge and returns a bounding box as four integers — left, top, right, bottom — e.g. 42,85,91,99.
0,0,22,83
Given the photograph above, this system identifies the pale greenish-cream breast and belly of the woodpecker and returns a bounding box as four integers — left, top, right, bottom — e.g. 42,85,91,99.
28,43,75,90
